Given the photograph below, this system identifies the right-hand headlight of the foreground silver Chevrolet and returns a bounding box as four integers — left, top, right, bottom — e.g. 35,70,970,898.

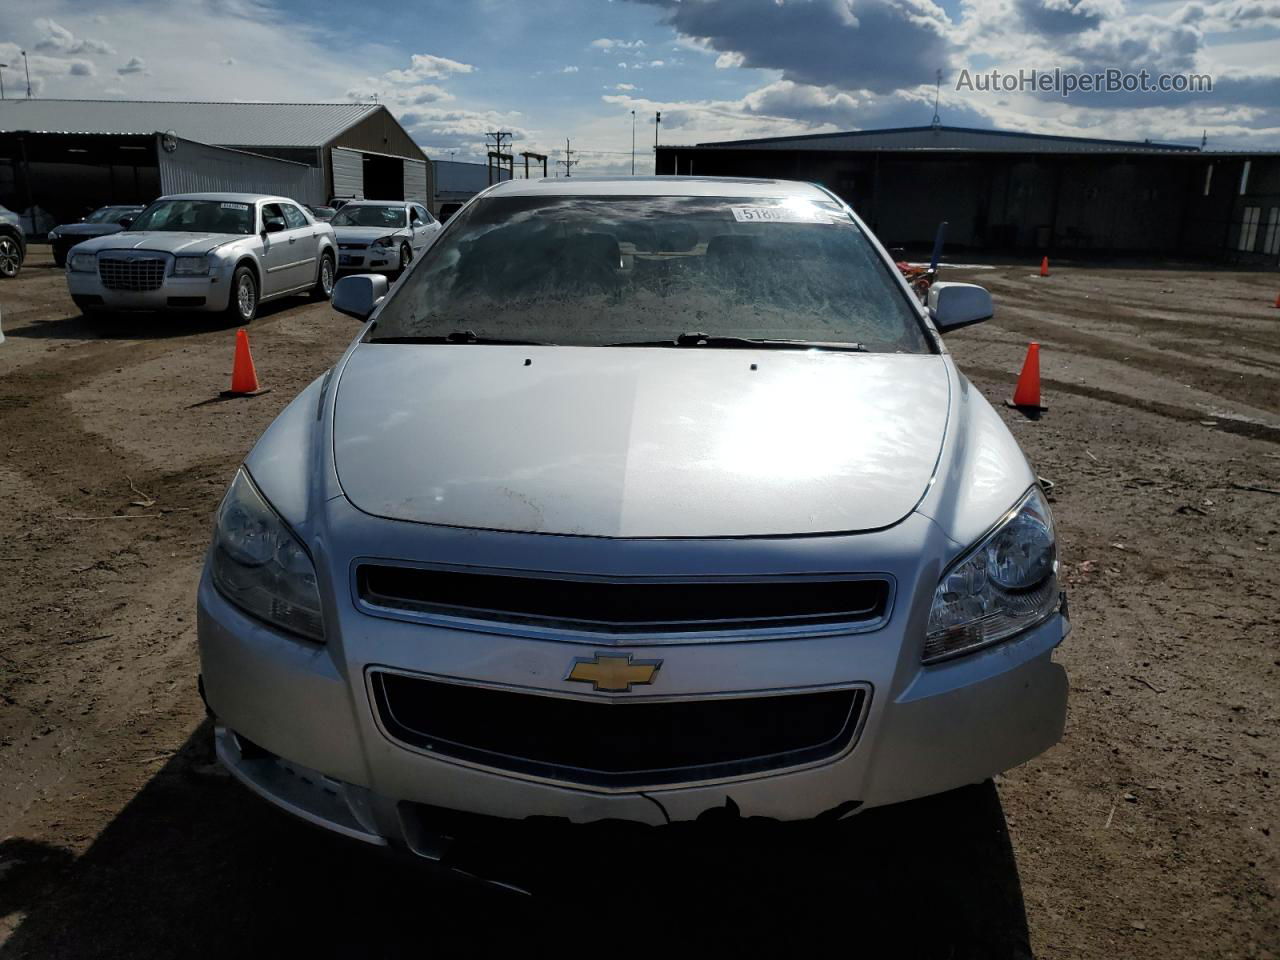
924,486,1059,663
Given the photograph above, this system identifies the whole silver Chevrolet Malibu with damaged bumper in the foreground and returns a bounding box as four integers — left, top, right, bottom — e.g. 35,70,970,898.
198,178,1069,859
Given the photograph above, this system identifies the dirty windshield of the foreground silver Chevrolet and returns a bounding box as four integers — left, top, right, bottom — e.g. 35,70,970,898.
371,197,929,353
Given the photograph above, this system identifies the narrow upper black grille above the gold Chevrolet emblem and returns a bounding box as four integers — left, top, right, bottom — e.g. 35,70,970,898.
356,563,890,634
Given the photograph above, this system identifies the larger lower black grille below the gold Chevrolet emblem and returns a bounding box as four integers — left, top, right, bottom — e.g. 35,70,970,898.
370,671,867,786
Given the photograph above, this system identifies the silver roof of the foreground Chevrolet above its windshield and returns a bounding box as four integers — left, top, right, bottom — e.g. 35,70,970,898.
484,177,831,200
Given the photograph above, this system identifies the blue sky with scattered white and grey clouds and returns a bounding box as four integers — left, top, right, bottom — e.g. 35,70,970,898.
0,0,1280,173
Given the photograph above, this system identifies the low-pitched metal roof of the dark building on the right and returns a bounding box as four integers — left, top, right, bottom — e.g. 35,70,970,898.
686,125,1201,154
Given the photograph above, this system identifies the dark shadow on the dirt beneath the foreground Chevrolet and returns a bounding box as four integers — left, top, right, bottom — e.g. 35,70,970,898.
0,723,1030,960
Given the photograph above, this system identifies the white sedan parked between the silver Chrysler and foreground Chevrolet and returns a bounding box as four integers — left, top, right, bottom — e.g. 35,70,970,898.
329,200,440,274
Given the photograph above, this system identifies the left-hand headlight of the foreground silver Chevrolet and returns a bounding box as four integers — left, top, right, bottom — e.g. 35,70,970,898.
210,470,324,643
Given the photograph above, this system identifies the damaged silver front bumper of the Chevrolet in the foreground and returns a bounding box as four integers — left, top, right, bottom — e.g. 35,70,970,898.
198,555,1069,858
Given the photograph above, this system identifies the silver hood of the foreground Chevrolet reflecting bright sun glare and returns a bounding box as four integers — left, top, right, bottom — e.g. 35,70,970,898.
333,343,950,538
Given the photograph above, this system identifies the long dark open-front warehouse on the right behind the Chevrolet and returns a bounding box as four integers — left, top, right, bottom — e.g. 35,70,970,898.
658,125,1280,266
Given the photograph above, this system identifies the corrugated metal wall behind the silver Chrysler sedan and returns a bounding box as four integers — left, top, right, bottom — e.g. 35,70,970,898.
156,137,325,204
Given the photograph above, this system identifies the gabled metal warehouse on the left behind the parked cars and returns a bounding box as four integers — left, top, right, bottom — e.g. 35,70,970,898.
0,100,434,233
